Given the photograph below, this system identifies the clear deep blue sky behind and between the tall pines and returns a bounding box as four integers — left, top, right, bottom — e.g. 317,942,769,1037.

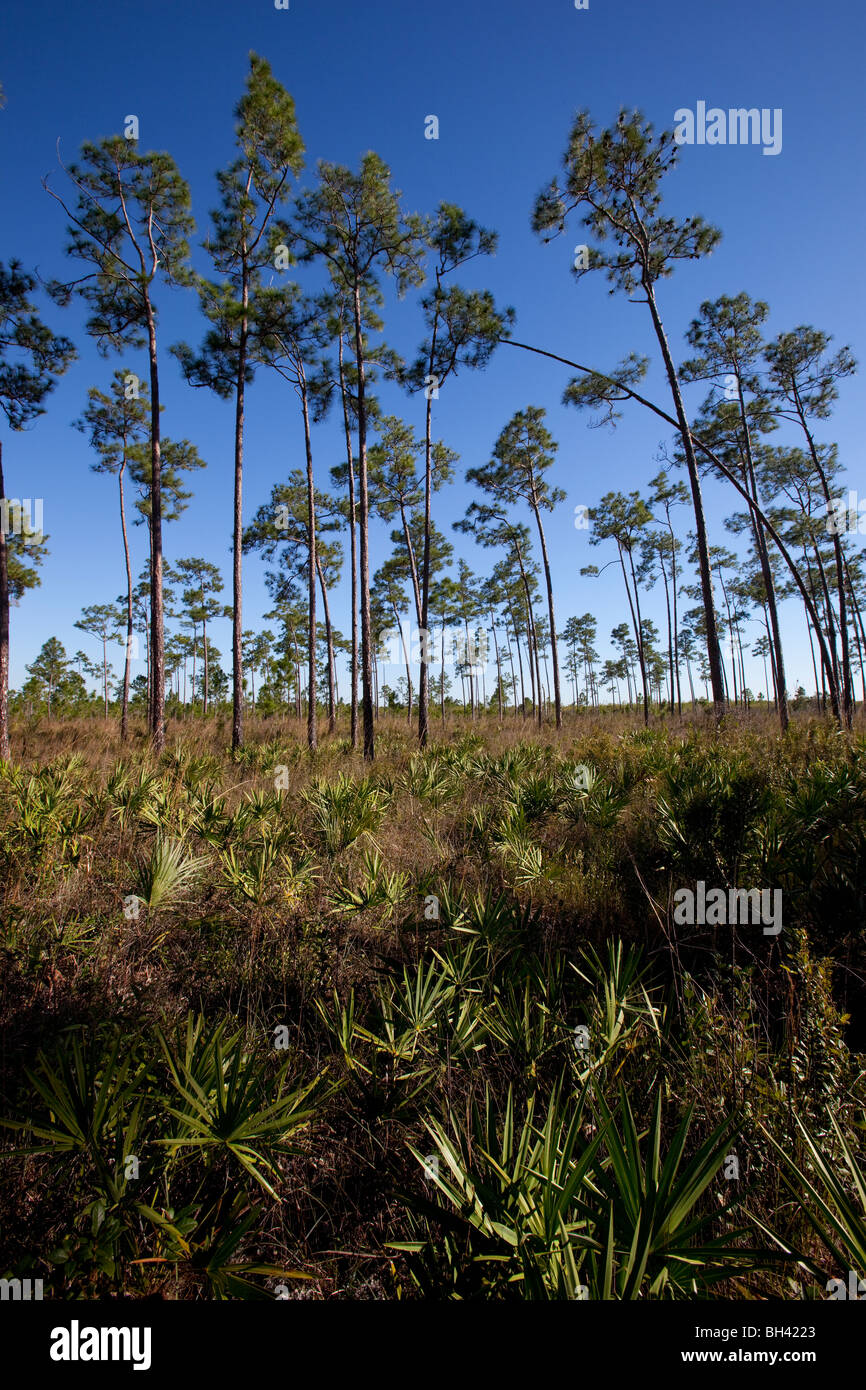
0,0,866,691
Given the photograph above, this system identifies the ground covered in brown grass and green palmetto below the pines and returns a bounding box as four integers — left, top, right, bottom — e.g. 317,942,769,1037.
0,710,866,1300
